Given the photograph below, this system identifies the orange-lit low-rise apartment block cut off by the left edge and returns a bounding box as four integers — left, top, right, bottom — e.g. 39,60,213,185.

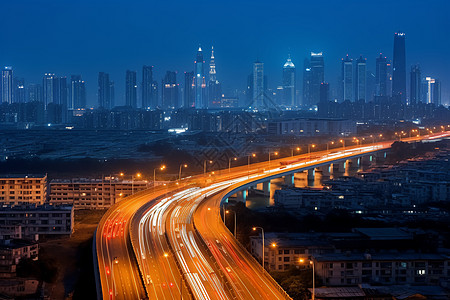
0,174,47,205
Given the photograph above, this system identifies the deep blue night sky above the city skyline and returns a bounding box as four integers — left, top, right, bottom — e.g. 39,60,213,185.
0,0,450,105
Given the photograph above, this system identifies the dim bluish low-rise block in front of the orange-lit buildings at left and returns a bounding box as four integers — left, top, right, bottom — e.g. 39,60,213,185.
0,204,74,239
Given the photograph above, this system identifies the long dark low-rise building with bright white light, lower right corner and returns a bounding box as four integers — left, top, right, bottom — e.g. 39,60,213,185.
310,253,450,286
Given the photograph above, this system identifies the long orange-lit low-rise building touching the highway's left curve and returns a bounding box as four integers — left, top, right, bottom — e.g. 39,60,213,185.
49,177,150,209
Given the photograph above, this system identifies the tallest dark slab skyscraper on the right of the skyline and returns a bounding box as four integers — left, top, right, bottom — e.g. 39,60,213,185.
392,32,406,103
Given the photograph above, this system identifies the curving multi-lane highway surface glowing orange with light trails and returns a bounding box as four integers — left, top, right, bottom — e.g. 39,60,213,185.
95,132,450,299
